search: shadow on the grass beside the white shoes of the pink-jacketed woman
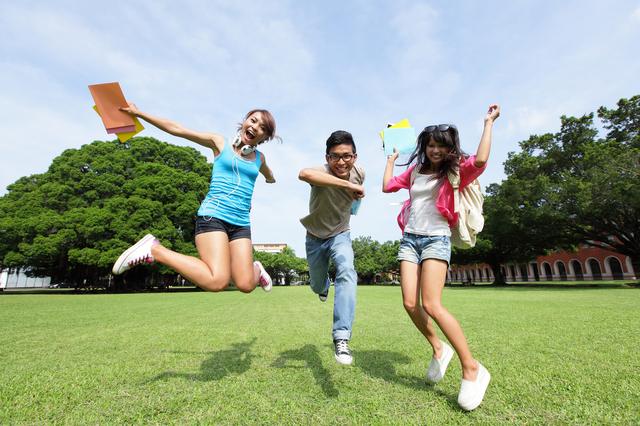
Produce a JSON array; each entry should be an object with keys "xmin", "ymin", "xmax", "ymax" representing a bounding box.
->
[{"xmin": 354, "ymin": 350, "xmax": 458, "ymax": 409}]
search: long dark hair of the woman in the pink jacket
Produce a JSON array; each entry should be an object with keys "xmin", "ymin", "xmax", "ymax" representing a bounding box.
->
[{"xmin": 401, "ymin": 124, "xmax": 467, "ymax": 180}]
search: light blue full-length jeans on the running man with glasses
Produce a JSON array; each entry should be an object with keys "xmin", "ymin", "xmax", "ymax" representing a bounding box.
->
[{"xmin": 306, "ymin": 232, "xmax": 358, "ymax": 340}]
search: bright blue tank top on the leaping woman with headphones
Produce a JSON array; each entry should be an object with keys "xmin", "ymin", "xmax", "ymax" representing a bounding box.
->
[{"xmin": 198, "ymin": 142, "xmax": 261, "ymax": 226}]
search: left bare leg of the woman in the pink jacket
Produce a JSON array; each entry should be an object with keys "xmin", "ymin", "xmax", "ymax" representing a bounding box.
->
[{"xmin": 400, "ymin": 260, "xmax": 442, "ymax": 358}]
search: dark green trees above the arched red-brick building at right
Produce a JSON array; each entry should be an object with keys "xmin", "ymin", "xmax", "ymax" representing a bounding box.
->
[{"xmin": 454, "ymin": 96, "xmax": 640, "ymax": 282}]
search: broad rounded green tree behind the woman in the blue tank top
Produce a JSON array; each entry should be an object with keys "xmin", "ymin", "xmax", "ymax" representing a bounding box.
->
[{"xmin": 0, "ymin": 138, "xmax": 211, "ymax": 286}]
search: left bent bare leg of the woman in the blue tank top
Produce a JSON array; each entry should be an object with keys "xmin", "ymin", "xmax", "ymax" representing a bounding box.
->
[{"xmin": 151, "ymin": 232, "xmax": 231, "ymax": 291}]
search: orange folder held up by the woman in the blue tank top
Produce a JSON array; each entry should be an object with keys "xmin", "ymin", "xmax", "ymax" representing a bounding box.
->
[{"xmin": 89, "ymin": 82, "xmax": 135, "ymax": 133}]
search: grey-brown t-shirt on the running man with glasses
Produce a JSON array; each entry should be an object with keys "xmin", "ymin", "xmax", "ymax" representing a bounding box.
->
[{"xmin": 300, "ymin": 164, "xmax": 364, "ymax": 238}]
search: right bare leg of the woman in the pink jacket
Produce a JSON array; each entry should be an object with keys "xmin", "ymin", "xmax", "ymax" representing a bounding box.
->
[{"xmin": 420, "ymin": 259, "xmax": 478, "ymax": 380}]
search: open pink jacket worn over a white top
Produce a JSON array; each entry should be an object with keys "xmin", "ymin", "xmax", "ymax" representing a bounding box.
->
[{"xmin": 385, "ymin": 155, "xmax": 487, "ymax": 230}]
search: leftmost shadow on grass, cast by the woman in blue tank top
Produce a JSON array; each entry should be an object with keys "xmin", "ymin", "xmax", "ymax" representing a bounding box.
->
[{"xmin": 149, "ymin": 337, "xmax": 256, "ymax": 382}]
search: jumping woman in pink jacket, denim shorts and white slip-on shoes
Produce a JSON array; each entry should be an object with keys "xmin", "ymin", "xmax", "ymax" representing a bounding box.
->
[{"xmin": 382, "ymin": 104, "xmax": 500, "ymax": 411}]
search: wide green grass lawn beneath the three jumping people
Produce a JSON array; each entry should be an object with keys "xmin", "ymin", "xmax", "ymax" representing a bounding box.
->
[{"xmin": 0, "ymin": 286, "xmax": 640, "ymax": 425}]
